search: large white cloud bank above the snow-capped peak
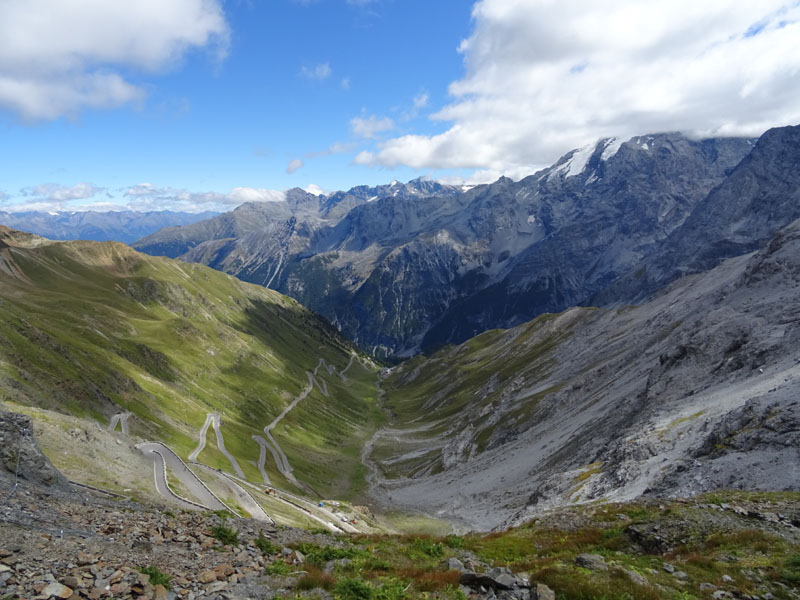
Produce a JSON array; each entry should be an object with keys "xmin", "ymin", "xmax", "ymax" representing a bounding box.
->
[{"xmin": 355, "ymin": 0, "xmax": 800, "ymax": 174}]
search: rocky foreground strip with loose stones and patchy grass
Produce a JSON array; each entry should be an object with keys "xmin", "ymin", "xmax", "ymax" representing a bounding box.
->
[{"xmin": 0, "ymin": 468, "xmax": 800, "ymax": 600}]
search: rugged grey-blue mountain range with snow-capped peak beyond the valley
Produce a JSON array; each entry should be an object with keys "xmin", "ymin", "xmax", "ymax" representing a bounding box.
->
[{"xmin": 134, "ymin": 127, "xmax": 800, "ymax": 357}]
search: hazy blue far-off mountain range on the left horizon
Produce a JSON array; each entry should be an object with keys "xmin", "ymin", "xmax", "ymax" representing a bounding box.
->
[{"xmin": 0, "ymin": 210, "xmax": 219, "ymax": 244}]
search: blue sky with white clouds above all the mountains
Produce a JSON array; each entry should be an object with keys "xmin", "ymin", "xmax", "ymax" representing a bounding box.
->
[{"xmin": 0, "ymin": 0, "xmax": 800, "ymax": 211}]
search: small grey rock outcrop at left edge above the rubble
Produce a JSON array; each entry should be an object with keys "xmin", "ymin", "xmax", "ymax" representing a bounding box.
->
[{"xmin": 0, "ymin": 411, "xmax": 69, "ymax": 488}]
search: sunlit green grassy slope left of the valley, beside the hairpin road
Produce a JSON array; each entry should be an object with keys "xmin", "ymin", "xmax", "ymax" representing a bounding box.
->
[{"xmin": 0, "ymin": 230, "xmax": 380, "ymax": 497}]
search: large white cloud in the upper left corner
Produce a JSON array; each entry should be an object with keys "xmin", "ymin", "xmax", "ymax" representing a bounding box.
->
[{"xmin": 0, "ymin": 0, "xmax": 228, "ymax": 120}]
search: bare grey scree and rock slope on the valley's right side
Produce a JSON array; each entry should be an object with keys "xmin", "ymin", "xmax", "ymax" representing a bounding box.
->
[{"xmin": 374, "ymin": 220, "xmax": 800, "ymax": 528}]
